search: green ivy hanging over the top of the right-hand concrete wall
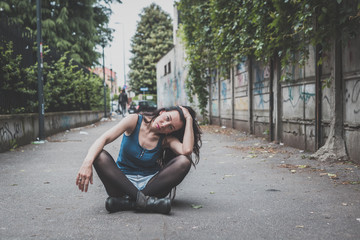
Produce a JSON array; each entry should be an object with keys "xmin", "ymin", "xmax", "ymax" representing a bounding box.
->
[{"xmin": 178, "ymin": 0, "xmax": 360, "ymax": 116}]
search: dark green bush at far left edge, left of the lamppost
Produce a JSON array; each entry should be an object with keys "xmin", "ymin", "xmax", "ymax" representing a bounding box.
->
[{"xmin": 0, "ymin": 41, "xmax": 37, "ymax": 114}]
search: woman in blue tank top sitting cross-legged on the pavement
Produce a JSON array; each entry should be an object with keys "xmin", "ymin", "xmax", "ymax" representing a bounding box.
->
[{"xmin": 76, "ymin": 106, "xmax": 201, "ymax": 214}]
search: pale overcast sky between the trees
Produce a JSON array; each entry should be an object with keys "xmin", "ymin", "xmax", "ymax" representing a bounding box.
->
[{"xmin": 99, "ymin": 0, "xmax": 174, "ymax": 87}]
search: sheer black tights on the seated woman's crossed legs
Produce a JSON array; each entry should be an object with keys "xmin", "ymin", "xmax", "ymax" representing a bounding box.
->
[{"xmin": 93, "ymin": 150, "xmax": 191, "ymax": 199}]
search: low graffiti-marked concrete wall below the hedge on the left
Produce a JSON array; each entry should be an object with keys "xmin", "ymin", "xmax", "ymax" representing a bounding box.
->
[{"xmin": 0, "ymin": 111, "xmax": 104, "ymax": 152}]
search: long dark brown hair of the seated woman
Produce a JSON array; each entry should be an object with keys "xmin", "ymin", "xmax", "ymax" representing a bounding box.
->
[{"xmin": 142, "ymin": 106, "xmax": 202, "ymax": 166}]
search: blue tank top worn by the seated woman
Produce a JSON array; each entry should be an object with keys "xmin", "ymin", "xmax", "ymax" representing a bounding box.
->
[{"xmin": 116, "ymin": 115, "xmax": 164, "ymax": 176}]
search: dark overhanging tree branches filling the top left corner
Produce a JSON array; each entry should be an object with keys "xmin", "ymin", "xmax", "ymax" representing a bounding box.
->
[{"xmin": 0, "ymin": 0, "xmax": 121, "ymax": 66}]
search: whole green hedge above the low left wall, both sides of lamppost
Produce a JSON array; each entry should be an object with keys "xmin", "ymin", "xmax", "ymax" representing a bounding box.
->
[{"xmin": 0, "ymin": 42, "xmax": 110, "ymax": 114}]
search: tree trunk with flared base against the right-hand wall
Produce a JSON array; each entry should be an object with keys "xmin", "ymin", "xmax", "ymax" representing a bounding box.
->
[{"xmin": 312, "ymin": 37, "xmax": 348, "ymax": 162}]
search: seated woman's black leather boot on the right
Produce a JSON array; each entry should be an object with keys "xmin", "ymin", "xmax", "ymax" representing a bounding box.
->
[{"xmin": 136, "ymin": 191, "xmax": 171, "ymax": 214}]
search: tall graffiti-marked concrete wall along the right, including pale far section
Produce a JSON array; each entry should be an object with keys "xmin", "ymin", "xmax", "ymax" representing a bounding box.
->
[{"xmin": 157, "ymin": 31, "xmax": 360, "ymax": 163}]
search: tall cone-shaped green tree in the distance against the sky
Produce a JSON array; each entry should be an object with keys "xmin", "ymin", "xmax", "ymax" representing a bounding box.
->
[{"xmin": 129, "ymin": 3, "xmax": 173, "ymax": 94}]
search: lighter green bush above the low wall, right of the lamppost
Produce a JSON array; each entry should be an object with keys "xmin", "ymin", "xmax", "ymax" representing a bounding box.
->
[{"xmin": 28, "ymin": 50, "xmax": 106, "ymax": 112}]
